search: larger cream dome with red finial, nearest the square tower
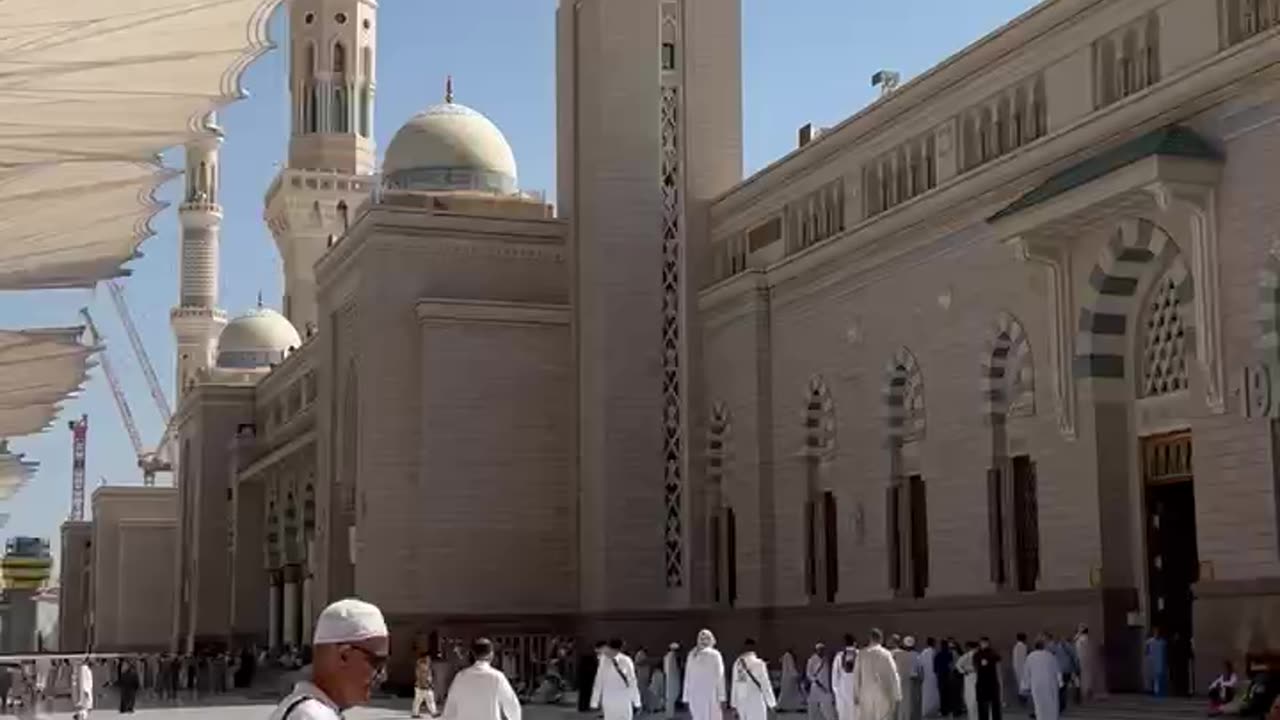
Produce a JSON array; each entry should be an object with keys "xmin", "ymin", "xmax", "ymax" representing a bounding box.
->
[{"xmin": 383, "ymin": 90, "xmax": 517, "ymax": 195}]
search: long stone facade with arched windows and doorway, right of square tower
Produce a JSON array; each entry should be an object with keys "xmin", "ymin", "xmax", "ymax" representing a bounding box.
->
[{"xmin": 700, "ymin": 1, "xmax": 1280, "ymax": 688}]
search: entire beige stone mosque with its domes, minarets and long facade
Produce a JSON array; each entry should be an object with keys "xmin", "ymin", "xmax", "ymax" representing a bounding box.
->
[{"xmin": 63, "ymin": 0, "xmax": 1280, "ymax": 691}]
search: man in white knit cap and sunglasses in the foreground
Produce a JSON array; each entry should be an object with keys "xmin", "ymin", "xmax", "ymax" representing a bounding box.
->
[{"xmin": 271, "ymin": 598, "xmax": 390, "ymax": 720}]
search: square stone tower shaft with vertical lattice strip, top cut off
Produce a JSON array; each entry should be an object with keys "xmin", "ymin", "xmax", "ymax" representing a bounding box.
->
[{"xmin": 557, "ymin": 0, "xmax": 742, "ymax": 611}]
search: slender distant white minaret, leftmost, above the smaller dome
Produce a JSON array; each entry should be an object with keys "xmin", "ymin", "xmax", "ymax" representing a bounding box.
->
[{"xmin": 169, "ymin": 114, "xmax": 227, "ymax": 401}]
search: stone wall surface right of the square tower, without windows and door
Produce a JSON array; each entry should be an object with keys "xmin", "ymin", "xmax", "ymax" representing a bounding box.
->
[{"xmin": 701, "ymin": 0, "xmax": 1280, "ymax": 686}]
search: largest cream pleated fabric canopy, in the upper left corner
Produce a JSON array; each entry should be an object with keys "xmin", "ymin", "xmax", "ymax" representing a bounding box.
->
[{"xmin": 0, "ymin": 0, "xmax": 279, "ymax": 290}]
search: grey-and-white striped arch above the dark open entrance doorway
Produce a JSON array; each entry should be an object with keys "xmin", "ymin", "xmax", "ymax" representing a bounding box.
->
[{"xmin": 1074, "ymin": 218, "xmax": 1196, "ymax": 380}]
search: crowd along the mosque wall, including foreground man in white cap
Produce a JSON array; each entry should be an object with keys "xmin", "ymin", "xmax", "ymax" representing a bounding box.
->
[{"xmin": 273, "ymin": 600, "xmax": 1111, "ymax": 720}]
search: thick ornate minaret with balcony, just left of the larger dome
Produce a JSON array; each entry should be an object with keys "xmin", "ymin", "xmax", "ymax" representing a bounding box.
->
[{"xmin": 265, "ymin": 0, "xmax": 378, "ymax": 337}]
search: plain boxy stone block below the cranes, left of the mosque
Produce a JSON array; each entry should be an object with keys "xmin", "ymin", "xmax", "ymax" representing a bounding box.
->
[{"xmin": 88, "ymin": 487, "xmax": 178, "ymax": 652}]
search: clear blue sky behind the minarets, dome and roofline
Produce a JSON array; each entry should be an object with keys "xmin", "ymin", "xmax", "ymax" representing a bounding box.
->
[{"xmin": 0, "ymin": 0, "xmax": 1036, "ymax": 557}]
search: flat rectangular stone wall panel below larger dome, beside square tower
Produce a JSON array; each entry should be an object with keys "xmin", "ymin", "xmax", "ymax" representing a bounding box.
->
[{"xmin": 412, "ymin": 309, "xmax": 577, "ymax": 615}]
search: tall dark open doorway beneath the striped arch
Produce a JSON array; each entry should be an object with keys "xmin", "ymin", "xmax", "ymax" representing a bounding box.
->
[{"xmin": 1142, "ymin": 432, "xmax": 1199, "ymax": 694}]
